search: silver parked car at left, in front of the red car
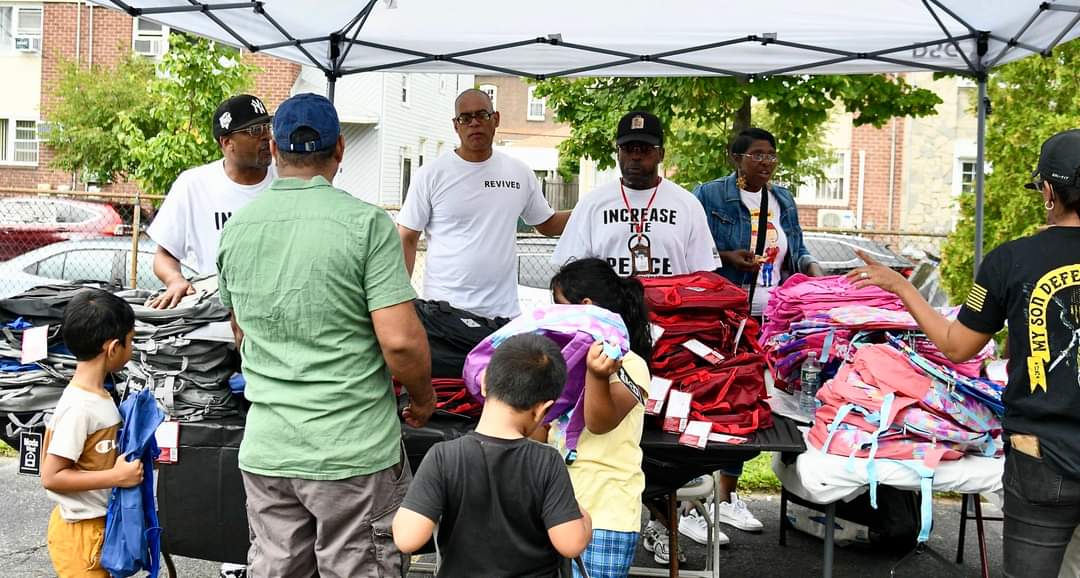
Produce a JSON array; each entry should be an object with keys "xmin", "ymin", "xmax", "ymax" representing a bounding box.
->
[{"xmin": 0, "ymin": 238, "xmax": 195, "ymax": 298}]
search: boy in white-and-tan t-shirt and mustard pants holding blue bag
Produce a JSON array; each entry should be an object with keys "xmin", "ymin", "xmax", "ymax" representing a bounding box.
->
[{"xmin": 41, "ymin": 290, "xmax": 143, "ymax": 578}]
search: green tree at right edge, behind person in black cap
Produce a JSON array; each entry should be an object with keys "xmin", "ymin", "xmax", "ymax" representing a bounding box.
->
[{"xmin": 942, "ymin": 41, "xmax": 1080, "ymax": 303}]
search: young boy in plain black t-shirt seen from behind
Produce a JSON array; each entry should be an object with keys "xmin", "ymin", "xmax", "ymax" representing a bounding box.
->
[{"xmin": 393, "ymin": 335, "xmax": 592, "ymax": 577}]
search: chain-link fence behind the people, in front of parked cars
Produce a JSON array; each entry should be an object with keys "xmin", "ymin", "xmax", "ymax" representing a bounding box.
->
[{"xmin": 0, "ymin": 189, "xmax": 945, "ymax": 305}]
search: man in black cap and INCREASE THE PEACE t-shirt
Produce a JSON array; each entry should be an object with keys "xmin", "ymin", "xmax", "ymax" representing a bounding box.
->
[{"xmin": 552, "ymin": 112, "xmax": 716, "ymax": 277}]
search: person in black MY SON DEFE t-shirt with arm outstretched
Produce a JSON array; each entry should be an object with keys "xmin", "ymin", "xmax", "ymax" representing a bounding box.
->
[{"xmin": 849, "ymin": 130, "xmax": 1080, "ymax": 578}]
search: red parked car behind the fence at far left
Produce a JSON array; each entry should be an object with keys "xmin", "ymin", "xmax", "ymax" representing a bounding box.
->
[{"xmin": 0, "ymin": 197, "xmax": 124, "ymax": 260}]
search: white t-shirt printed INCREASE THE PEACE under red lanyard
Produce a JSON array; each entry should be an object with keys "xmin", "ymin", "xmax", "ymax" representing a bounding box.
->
[{"xmin": 552, "ymin": 178, "xmax": 716, "ymax": 277}]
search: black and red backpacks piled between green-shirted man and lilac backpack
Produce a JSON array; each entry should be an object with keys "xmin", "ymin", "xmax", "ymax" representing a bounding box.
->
[{"xmin": 408, "ymin": 299, "xmax": 510, "ymax": 417}]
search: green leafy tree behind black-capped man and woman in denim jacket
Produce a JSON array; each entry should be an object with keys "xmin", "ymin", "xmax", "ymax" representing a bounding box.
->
[{"xmin": 537, "ymin": 76, "xmax": 941, "ymax": 187}]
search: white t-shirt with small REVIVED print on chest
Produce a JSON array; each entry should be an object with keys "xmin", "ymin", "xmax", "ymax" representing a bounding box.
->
[{"xmin": 397, "ymin": 151, "xmax": 555, "ymax": 317}]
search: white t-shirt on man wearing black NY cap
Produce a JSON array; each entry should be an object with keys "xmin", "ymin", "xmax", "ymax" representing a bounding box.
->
[{"xmin": 146, "ymin": 159, "xmax": 276, "ymax": 274}]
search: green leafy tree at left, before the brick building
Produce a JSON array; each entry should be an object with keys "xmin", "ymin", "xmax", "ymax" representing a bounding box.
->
[{"xmin": 46, "ymin": 33, "xmax": 254, "ymax": 193}]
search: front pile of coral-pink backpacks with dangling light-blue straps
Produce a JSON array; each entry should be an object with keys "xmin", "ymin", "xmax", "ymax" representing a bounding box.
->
[{"xmin": 807, "ymin": 337, "xmax": 1001, "ymax": 541}]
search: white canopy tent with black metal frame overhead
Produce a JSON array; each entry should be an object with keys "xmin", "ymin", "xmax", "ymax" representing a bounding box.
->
[{"xmin": 92, "ymin": 0, "xmax": 1080, "ymax": 272}]
